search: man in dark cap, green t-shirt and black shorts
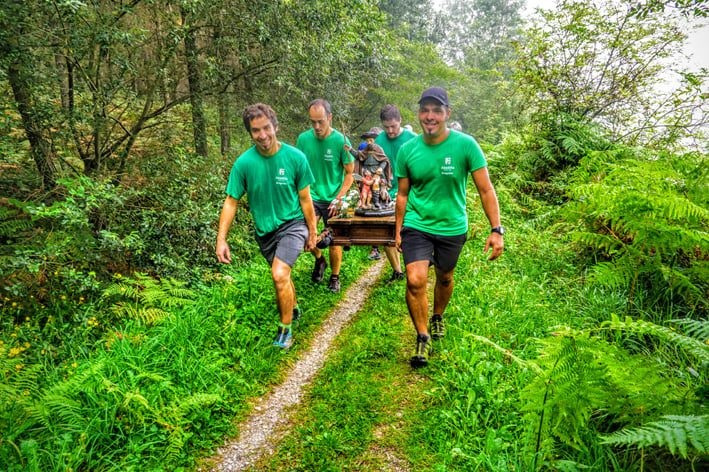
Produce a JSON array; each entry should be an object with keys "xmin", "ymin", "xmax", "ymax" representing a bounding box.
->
[{"xmin": 395, "ymin": 87, "xmax": 504, "ymax": 367}]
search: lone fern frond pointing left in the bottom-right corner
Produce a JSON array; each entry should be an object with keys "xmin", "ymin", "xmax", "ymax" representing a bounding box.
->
[{"xmin": 602, "ymin": 415, "xmax": 709, "ymax": 459}]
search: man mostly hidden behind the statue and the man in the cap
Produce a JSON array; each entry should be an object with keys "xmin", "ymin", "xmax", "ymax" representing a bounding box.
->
[{"xmin": 370, "ymin": 105, "xmax": 416, "ymax": 282}]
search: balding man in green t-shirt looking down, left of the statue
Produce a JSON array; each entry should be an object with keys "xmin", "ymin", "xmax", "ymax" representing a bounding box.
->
[{"xmin": 295, "ymin": 98, "xmax": 354, "ymax": 292}]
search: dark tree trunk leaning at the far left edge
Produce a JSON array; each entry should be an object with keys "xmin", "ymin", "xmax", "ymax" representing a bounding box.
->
[{"xmin": 7, "ymin": 55, "xmax": 57, "ymax": 190}]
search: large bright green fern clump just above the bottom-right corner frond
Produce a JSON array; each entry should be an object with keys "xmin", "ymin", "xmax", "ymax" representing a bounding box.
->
[{"xmin": 520, "ymin": 318, "xmax": 696, "ymax": 469}]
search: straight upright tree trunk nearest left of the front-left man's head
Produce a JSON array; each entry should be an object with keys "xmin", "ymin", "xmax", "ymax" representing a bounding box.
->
[{"xmin": 182, "ymin": 9, "xmax": 207, "ymax": 157}]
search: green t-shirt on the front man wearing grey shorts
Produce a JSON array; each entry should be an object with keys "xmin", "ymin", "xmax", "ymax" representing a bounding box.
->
[{"xmin": 226, "ymin": 142, "xmax": 313, "ymax": 236}]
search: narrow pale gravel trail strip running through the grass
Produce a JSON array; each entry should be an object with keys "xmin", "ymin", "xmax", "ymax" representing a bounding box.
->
[{"xmin": 211, "ymin": 258, "xmax": 388, "ymax": 472}]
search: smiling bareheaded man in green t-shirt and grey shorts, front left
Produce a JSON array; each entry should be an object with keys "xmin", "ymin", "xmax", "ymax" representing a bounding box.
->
[{"xmin": 216, "ymin": 103, "xmax": 317, "ymax": 349}]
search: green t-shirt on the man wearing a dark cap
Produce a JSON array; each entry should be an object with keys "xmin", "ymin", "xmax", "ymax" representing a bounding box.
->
[{"xmin": 396, "ymin": 130, "xmax": 487, "ymax": 236}]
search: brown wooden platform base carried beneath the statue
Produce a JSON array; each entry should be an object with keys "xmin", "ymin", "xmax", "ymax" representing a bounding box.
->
[{"xmin": 328, "ymin": 215, "xmax": 395, "ymax": 246}]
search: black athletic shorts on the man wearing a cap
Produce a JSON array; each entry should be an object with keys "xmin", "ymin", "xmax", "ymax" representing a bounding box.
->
[{"xmin": 401, "ymin": 226, "xmax": 467, "ymax": 272}]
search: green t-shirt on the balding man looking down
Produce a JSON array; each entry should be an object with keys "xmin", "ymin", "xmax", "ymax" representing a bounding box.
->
[{"xmin": 295, "ymin": 128, "xmax": 354, "ymax": 202}]
